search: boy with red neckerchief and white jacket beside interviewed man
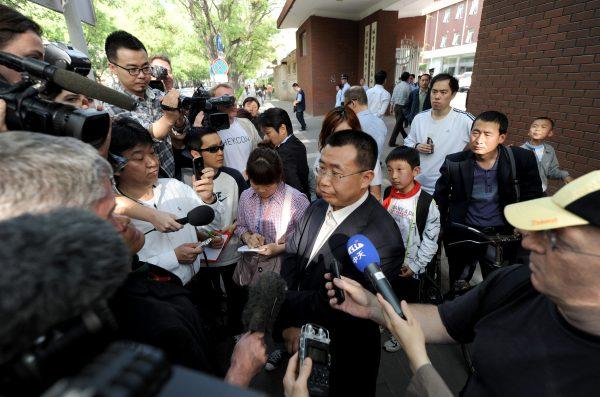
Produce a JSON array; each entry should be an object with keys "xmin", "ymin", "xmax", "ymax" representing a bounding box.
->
[{"xmin": 383, "ymin": 146, "xmax": 440, "ymax": 352}]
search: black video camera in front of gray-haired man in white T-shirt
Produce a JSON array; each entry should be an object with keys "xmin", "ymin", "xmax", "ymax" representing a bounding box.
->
[{"xmin": 161, "ymin": 87, "xmax": 235, "ymax": 131}]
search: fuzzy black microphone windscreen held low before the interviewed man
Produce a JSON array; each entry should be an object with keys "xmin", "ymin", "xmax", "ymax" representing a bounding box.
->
[{"xmin": 242, "ymin": 271, "xmax": 287, "ymax": 332}]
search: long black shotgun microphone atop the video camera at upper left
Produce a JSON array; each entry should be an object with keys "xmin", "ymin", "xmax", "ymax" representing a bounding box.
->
[{"xmin": 0, "ymin": 51, "xmax": 137, "ymax": 110}]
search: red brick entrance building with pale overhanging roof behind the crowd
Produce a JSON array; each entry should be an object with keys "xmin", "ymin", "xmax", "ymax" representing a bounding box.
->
[{"xmin": 277, "ymin": 0, "xmax": 426, "ymax": 115}]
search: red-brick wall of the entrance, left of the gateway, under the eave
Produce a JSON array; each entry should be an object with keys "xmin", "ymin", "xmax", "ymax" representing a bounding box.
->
[{"xmin": 296, "ymin": 16, "xmax": 359, "ymax": 115}]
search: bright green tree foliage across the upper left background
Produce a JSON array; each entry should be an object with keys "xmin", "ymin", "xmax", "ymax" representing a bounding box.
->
[{"xmin": 0, "ymin": 0, "xmax": 284, "ymax": 81}]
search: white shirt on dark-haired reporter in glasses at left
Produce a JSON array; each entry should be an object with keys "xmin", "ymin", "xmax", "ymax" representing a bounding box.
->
[{"xmin": 132, "ymin": 178, "xmax": 223, "ymax": 285}]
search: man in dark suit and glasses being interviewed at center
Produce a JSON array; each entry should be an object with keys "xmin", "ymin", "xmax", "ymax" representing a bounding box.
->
[{"xmin": 276, "ymin": 131, "xmax": 404, "ymax": 396}]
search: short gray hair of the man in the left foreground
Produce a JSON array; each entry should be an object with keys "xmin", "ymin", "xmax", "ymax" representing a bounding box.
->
[{"xmin": 0, "ymin": 131, "xmax": 114, "ymax": 220}]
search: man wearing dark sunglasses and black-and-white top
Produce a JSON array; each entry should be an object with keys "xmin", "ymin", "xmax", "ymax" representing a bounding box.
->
[{"xmin": 187, "ymin": 128, "xmax": 248, "ymax": 335}]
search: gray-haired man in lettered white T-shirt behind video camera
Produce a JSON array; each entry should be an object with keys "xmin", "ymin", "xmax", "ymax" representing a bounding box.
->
[{"xmin": 209, "ymin": 83, "xmax": 262, "ymax": 178}]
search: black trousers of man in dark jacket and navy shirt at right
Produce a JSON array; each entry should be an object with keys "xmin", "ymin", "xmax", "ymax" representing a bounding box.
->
[{"xmin": 444, "ymin": 225, "xmax": 520, "ymax": 288}]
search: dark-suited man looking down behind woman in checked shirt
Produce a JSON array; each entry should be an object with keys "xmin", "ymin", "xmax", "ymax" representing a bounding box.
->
[{"xmin": 259, "ymin": 108, "xmax": 310, "ymax": 200}]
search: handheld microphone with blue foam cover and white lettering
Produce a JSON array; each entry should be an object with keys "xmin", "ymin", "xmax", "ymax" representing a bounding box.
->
[{"xmin": 346, "ymin": 234, "xmax": 404, "ymax": 317}]
